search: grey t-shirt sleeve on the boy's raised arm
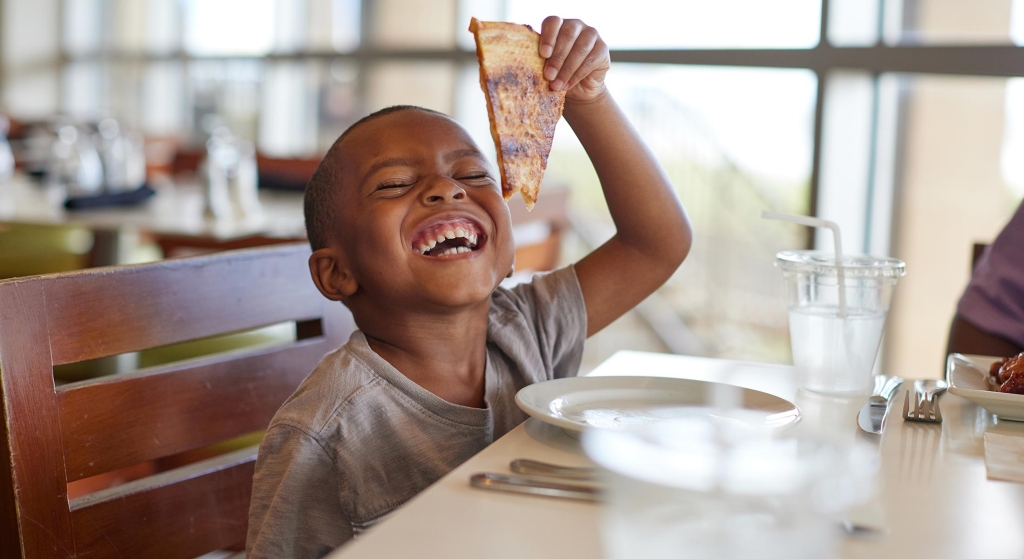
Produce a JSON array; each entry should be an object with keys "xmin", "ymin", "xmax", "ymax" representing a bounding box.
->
[{"xmin": 493, "ymin": 265, "xmax": 587, "ymax": 378}]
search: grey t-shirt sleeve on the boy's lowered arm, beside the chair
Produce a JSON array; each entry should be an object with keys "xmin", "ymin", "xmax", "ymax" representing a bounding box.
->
[{"xmin": 246, "ymin": 424, "xmax": 352, "ymax": 559}]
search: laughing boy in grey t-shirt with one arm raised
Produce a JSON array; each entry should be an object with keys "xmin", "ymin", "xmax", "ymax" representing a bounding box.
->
[{"xmin": 248, "ymin": 16, "xmax": 691, "ymax": 559}]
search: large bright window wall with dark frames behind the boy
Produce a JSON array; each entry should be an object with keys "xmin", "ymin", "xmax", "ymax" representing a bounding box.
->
[{"xmin": 3, "ymin": 0, "xmax": 1024, "ymax": 377}]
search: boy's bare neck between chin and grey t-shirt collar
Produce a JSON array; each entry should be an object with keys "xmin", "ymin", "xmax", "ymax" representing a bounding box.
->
[{"xmin": 359, "ymin": 300, "xmax": 490, "ymax": 407}]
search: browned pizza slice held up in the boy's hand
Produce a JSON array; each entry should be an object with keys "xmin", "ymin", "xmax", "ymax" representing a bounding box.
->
[{"xmin": 469, "ymin": 17, "xmax": 565, "ymax": 209}]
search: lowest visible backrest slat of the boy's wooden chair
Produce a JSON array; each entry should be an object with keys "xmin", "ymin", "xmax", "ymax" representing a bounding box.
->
[{"xmin": 72, "ymin": 447, "xmax": 256, "ymax": 559}]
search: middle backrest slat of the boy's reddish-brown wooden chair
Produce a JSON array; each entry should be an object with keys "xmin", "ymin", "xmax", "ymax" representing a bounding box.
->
[{"xmin": 57, "ymin": 340, "xmax": 323, "ymax": 481}]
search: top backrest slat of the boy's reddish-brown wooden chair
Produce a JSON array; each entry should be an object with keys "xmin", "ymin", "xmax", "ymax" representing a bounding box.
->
[{"xmin": 44, "ymin": 246, "xmax": 323, "ymax": 364}]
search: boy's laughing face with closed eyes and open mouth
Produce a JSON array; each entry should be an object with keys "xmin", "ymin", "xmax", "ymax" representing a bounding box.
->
[{"xmin": 332, "ymin": 110, "xmax": 514, "ymax": 310}]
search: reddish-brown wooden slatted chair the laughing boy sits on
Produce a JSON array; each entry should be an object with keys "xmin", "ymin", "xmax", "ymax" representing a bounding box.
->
[{"xmin": 0, "ymin": 245, "xmax": 354, "ymax": 558}]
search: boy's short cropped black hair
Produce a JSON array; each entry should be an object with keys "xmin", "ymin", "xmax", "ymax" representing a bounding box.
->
[{"xmin": 302, "ymin": 104, "xmax": 451, "ymax": 251}]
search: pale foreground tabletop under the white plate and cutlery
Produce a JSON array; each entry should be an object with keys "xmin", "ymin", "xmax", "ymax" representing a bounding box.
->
[{"xmin": 328, "ymin": 351, "xmax": 1024, "ymax": 559}]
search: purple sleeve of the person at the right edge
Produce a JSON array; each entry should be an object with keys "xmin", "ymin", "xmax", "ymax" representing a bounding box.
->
[{"xmin": 956, "ymin": 203, "xmax": 1024, "ymax": 346}]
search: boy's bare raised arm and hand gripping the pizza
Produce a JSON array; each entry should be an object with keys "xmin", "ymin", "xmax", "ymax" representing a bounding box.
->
[{"xmin": 541, "ymin": 16, "xmax": 693, "ymax": 336}]
